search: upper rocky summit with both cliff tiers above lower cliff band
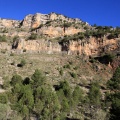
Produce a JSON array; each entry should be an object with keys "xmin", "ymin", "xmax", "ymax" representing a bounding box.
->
[{"xmin": 0, "ymin": 13, "xmax": 89, "ymax": 38}]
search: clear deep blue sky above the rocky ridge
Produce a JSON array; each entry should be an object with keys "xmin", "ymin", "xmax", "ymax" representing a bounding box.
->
[{"xmin": 0, "ymin": 0, "xmax": 120, "ymax": 27}]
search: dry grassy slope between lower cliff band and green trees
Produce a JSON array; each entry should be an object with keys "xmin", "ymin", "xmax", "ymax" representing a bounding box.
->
[{"xmin": 0, "ymin": 53, "xmax": 111, "ymax": 85}]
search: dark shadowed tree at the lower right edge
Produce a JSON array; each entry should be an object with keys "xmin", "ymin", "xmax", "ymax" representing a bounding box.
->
[{"xmin": 106, "ymin": 67, "xmax": 120, "ymax": 120}]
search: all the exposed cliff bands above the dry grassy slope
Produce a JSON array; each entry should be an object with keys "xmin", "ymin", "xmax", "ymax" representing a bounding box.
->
[{"xmin": 0, "ymin": 13, "xmax": 120, "ymax": 56}]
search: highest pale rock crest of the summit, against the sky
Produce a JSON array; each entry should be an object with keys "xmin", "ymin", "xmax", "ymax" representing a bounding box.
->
[{"xmin": 21, "ymin": 13, "xmax": 82, "ymax": 29}]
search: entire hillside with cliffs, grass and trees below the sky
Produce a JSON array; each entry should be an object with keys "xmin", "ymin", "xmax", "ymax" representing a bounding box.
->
[{"xmin": 0, "ymin": 13, "xmax": 120, "ymax": 120}]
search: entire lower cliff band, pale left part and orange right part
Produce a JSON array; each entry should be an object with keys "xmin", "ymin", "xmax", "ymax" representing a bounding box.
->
[{"xmin": 17, "ymin": 37, "xmax": 120, "ymax": 56}]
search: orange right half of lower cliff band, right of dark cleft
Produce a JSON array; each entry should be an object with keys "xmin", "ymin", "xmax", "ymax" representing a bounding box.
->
[{"xmin": 68, "ymin": 37, "xmax": 120, "ymax": 56}]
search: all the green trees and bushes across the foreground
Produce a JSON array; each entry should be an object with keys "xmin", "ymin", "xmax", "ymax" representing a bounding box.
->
[{"xmin": 0, "ymin": 63, "xmax": 120, "ymax": 120}]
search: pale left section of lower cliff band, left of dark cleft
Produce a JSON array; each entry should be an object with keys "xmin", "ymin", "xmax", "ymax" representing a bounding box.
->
[{"xmin": 15, "ymin": 39, "xmax": 61, "ymax": 53}]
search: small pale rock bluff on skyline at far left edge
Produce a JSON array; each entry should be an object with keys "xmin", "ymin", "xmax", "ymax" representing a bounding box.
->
[{"xmin": 0, "ymin": 19, "xmax": 20, "ymax": 28}]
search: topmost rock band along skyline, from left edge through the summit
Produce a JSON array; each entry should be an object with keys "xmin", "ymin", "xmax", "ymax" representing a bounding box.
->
[{"xmin": 0, "ymin": 13, "xmax": 82, "ymax": 29}]
